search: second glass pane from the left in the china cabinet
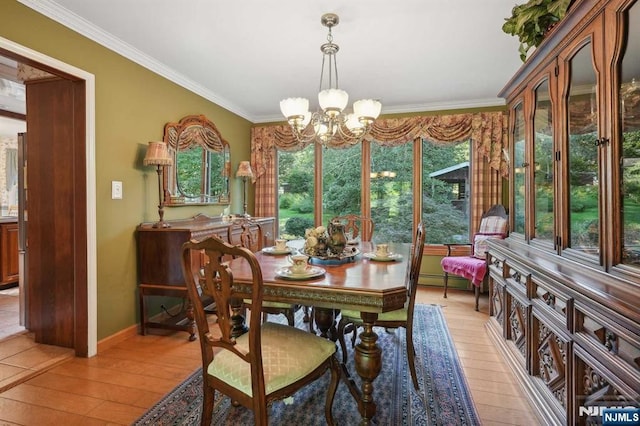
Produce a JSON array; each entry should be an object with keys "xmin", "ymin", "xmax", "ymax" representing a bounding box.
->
[{"xmin": 533, "ymin": 80, "xmax": 554, "ymax": 241}]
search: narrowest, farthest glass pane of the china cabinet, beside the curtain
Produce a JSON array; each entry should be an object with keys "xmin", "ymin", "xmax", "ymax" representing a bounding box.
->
[{"xmin": 513, "ymin": 103, "xmax": 526, "ymax": 234}]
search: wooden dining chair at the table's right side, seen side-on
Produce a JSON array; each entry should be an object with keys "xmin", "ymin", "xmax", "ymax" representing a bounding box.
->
[{"xmin": 337, "ymin": 222, "xmax": 425, "ymax": 390}]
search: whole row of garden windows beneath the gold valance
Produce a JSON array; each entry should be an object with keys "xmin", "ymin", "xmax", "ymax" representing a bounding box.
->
[{"xmin": 278, "ymin": 135, "xmax": 480, "ymax": 244}]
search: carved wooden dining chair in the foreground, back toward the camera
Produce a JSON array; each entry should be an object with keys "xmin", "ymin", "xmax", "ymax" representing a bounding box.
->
[{"xmin": 182, "ymin": 236, "xmax": 340, "ymax": 425}]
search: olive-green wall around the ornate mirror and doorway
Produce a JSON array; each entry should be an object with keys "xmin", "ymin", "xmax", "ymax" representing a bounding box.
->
[{"xmin": 0, "ymin": 0, "xmax": 252, "ymax": 340}]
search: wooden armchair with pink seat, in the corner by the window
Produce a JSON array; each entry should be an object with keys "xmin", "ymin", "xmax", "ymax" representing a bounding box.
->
[{"xmin": 440, "ymin": 204, "xmax": 508, "ymax": 311}]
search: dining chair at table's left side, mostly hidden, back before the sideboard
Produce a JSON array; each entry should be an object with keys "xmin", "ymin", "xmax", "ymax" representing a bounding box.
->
[{"xmin": 227, "ymin": 218, "xmax": 299, "ymax": 327}]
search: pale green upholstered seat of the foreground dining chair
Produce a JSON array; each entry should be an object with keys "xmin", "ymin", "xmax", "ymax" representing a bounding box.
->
[{"xmin": 207, "ymin": 322, "xmax": 336, "ymax": 396}]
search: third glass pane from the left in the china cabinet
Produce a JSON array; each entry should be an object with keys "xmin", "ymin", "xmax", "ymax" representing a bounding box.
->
[{"xmin": 567, "ymin": 43, "xmax": 600, "ymax": 255}]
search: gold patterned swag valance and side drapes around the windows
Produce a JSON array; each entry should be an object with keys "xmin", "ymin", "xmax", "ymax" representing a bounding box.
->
[{"xmin": 251, "ymin": 111, "xmax": 508, "ymax": 223}]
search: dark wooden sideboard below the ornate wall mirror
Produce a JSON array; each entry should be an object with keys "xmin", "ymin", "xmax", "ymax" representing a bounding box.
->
[{"xmin": 137, "ymin": 214, "xmax": 275, "ymax": 340}]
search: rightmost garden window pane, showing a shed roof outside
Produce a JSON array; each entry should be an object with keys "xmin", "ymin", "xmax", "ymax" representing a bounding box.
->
[{"xmin": 422, "ymin": 140, "xmax": 470, "ymax": 244}]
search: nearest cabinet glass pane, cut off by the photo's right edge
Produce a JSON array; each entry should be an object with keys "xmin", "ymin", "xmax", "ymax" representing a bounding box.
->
[{"xmin": 619, "ymin": 2, "xmax": 640, "ymax": 266}]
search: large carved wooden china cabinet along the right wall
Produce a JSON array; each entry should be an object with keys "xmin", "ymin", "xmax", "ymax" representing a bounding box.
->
[{"xmin": 488, "ymin": 0, "xmax": 640, "ymax": 425}]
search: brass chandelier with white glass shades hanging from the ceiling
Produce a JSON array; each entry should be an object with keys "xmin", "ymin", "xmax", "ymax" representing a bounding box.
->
[{"xmin": 280, "ymin": 13, "xmax": 382, "ymax": 146}]
